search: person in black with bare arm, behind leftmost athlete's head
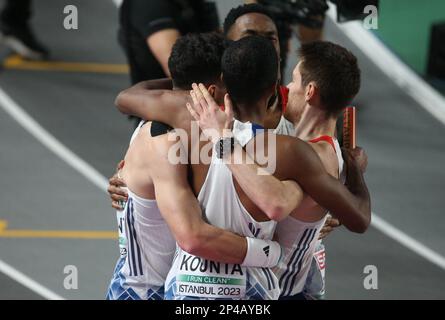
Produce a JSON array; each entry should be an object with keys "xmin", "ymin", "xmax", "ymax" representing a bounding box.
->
[{"xmin": 119, "ymin": 0, "xmax": 219, "ymax": 84}]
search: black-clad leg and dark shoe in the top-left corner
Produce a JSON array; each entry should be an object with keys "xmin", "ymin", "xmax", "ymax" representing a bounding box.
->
[{"xmin": 0, "ymin": 0, "xmax": 49, "ymax": 60}]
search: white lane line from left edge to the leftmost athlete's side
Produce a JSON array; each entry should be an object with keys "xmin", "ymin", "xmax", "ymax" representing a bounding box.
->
[{"xmin": 0, "ymin": 88, "xmax": 108, "ymax": 191}]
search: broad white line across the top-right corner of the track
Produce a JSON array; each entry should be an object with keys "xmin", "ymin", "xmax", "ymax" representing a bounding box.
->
[{"xmin": 327, "ymin": 4, "xmax": 445, "ymax": 125}]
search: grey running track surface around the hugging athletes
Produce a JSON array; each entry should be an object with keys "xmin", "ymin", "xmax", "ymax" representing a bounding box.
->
[{"xmin": 0, "ymin": 0, "xmax": 445, "ymax": 299}]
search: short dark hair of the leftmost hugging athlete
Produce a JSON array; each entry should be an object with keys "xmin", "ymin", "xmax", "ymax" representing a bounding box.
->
[{"xmin": 168, "ymin": 32, "xmax": 227, "ymax": 90}]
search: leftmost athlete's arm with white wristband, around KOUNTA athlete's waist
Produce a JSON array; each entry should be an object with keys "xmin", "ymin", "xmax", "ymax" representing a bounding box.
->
[{"xmin": 149, "ymin": 135, "xmax": 281, "ymax": 267}]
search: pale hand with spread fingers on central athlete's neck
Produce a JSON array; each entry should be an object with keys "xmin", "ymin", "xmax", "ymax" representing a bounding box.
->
[{"xmin": 187, "ymin": 83, "xmax": 233, "ymax": 143}]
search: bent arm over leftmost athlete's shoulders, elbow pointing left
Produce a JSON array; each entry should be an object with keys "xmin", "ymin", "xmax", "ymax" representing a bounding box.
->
[{"xmin": 115, "ymin": 79, "xmax": 191, "ymax": 129}]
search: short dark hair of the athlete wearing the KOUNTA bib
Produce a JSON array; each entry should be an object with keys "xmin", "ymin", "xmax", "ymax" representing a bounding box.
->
[{"xmin": 221, "ymin": 36, "xmax": 278, "ymax": 104}]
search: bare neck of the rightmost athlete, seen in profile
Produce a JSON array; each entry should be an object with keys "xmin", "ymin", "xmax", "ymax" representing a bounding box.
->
[{"xmin": 294, "ymin": 104, "xmax": 337, "ymax": 141}]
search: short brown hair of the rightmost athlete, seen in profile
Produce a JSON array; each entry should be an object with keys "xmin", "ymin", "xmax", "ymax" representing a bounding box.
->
[{"xmin": 298, "ymin": 41, "xmax": 360, "ymax": 116}]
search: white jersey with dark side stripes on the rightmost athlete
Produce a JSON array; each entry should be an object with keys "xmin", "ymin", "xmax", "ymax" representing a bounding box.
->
[{"xmin": 274, "ymin": 139, "xmax": 344, "ymax": 297}]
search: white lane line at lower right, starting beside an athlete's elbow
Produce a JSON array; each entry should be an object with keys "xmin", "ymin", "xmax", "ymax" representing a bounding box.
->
[{"xmin": 371, "ymin": 213, "xmax": 445, "ymax": 270}]
